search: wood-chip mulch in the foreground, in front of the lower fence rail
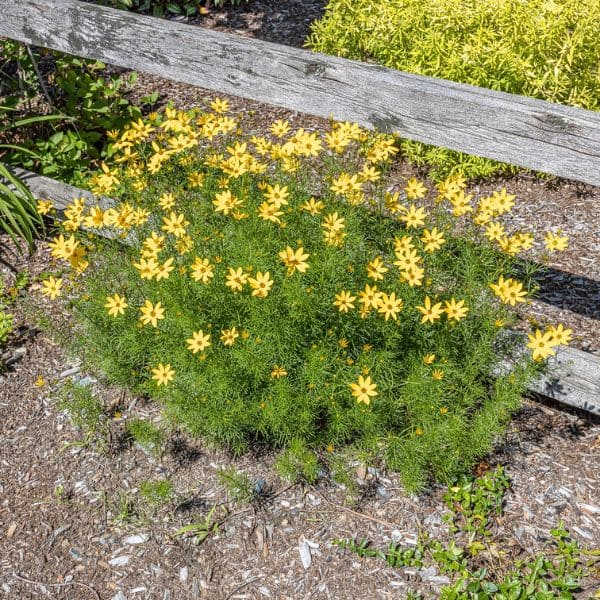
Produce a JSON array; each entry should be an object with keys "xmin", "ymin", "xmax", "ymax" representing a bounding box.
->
[{"xmin": 0, "ymin": 238, "xmax": 600, "ymax": 600}]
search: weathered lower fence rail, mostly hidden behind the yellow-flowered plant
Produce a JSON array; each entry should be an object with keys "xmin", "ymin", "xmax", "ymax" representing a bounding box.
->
[{"xmin": 7, "ymin": 169, "xmax": 600, "ymax": 416}]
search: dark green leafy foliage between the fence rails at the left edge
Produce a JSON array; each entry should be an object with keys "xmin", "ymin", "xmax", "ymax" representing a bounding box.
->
[{"xmin": 0, "ymin": 40, "xmax": 157, "ymax": 185}]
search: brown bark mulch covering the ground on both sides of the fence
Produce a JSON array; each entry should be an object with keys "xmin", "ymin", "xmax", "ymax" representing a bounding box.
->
[{"xmin": 0, "ymin": 0, "xmax": 600, "ymax": 600}]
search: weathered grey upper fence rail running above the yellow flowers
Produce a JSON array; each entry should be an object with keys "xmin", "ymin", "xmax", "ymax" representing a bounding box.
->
[{"xmin": 0, "ymin": 0, "xmax": 600, "ymax": 185}]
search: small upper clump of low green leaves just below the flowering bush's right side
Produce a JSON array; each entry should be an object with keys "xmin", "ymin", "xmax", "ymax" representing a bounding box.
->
[{"xmin": 443, "ymin": 465, "xmax": 510, "ymax": 536}]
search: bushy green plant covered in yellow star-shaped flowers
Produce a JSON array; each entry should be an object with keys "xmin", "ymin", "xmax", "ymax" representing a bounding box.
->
[{"xmin": 38, "ymin": 100, "xmax": 570, "ymax": 489}]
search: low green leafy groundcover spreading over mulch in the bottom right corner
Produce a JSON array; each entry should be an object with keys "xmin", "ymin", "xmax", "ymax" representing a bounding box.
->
[{"xmin": 333, "ymin": 467, "xmax": 600, "ymax": 600}]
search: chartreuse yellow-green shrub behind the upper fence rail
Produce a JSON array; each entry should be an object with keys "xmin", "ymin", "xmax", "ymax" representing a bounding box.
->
[{"xmin": 308, "ymin": 0, "xmax": 600, "ymax": 179}]
